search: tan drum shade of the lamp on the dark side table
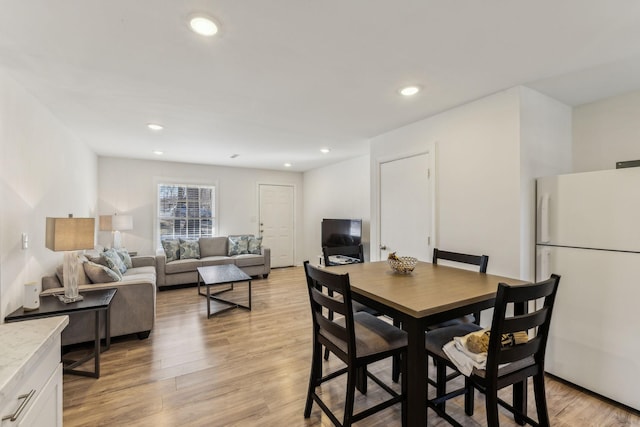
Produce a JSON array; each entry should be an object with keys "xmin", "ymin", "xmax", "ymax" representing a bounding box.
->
[{"xmin": 45, "ymin": 217, "xmax": 96, "ymax": 252}]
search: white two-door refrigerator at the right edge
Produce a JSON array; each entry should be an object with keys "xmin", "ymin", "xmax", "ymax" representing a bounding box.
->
[{"xmin": 536, "ymin": 168, "xmax": 640, "ymax": 410}]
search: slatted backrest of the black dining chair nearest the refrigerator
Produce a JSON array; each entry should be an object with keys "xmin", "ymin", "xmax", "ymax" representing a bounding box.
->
[{"xmin": 486, "ymin": 274, "xmax": 560, "ymax": 378}]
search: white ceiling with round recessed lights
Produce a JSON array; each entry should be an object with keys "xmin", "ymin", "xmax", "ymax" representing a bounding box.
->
[{"xmin": 0, "ymin": 0, "xmax": 640, "ymax": 171}]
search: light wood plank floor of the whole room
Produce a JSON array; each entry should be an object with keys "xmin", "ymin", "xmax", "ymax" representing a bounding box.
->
[{"xmin": 64, "ymin": 267, "xmax": 640, "ymax": 427}]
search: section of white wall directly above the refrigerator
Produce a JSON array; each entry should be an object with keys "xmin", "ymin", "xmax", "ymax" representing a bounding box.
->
[{"xmin": 573, "ymin": 91, "xmax": 640, "ymax": 172}]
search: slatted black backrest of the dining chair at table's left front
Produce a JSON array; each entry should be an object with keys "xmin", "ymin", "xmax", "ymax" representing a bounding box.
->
[{"xmin": 304, "ymin": 261, "xmax": 356, "ymax": 363}]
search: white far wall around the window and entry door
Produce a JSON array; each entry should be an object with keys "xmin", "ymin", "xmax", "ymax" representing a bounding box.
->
[{"xmin": 98, "ymin": 157, "xmax": 304, "ymax": 264}]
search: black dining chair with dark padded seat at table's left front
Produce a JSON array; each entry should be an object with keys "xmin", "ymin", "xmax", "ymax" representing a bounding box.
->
[{"xmin": 304, "ymin": 261, "xmax": 407, "ymax": 427}]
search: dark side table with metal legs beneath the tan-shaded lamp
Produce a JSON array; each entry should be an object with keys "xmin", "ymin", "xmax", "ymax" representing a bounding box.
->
[{"xmin": 4, "ymin": 289, "xmax": 117, "ymax": 378}]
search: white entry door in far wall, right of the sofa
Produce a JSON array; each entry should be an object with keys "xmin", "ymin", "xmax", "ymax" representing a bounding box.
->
[{"xmin": 259, "ymin": 184, "xmax": 294, "ymax": 267}]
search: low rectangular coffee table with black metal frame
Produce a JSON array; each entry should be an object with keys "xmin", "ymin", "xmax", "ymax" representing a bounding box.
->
[{"xmin": 198, "ymin": 264, "xmax": 251, "ymax": 319}]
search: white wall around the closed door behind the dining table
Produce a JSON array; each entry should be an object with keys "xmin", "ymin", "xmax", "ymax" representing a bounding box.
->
[{"xmin": 371, "ymin": 88, "xmax": 520, "ymax": 276}]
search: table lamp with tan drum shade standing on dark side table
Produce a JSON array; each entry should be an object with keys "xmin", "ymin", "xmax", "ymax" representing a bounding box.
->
[{"xmin": 45, "ymin": 215, "xmax": 96, "ymax": 303}]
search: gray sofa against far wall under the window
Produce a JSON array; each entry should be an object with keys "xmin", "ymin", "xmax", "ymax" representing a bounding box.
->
[{"xmin": 156, "ymin": 235, "xmax": 271, "ymax": 288}]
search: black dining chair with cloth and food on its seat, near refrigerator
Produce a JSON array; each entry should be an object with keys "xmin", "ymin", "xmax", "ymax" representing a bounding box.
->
[{"xmin": 425, "ymin": 274, "xmax": 560, "ymax": 427}]
